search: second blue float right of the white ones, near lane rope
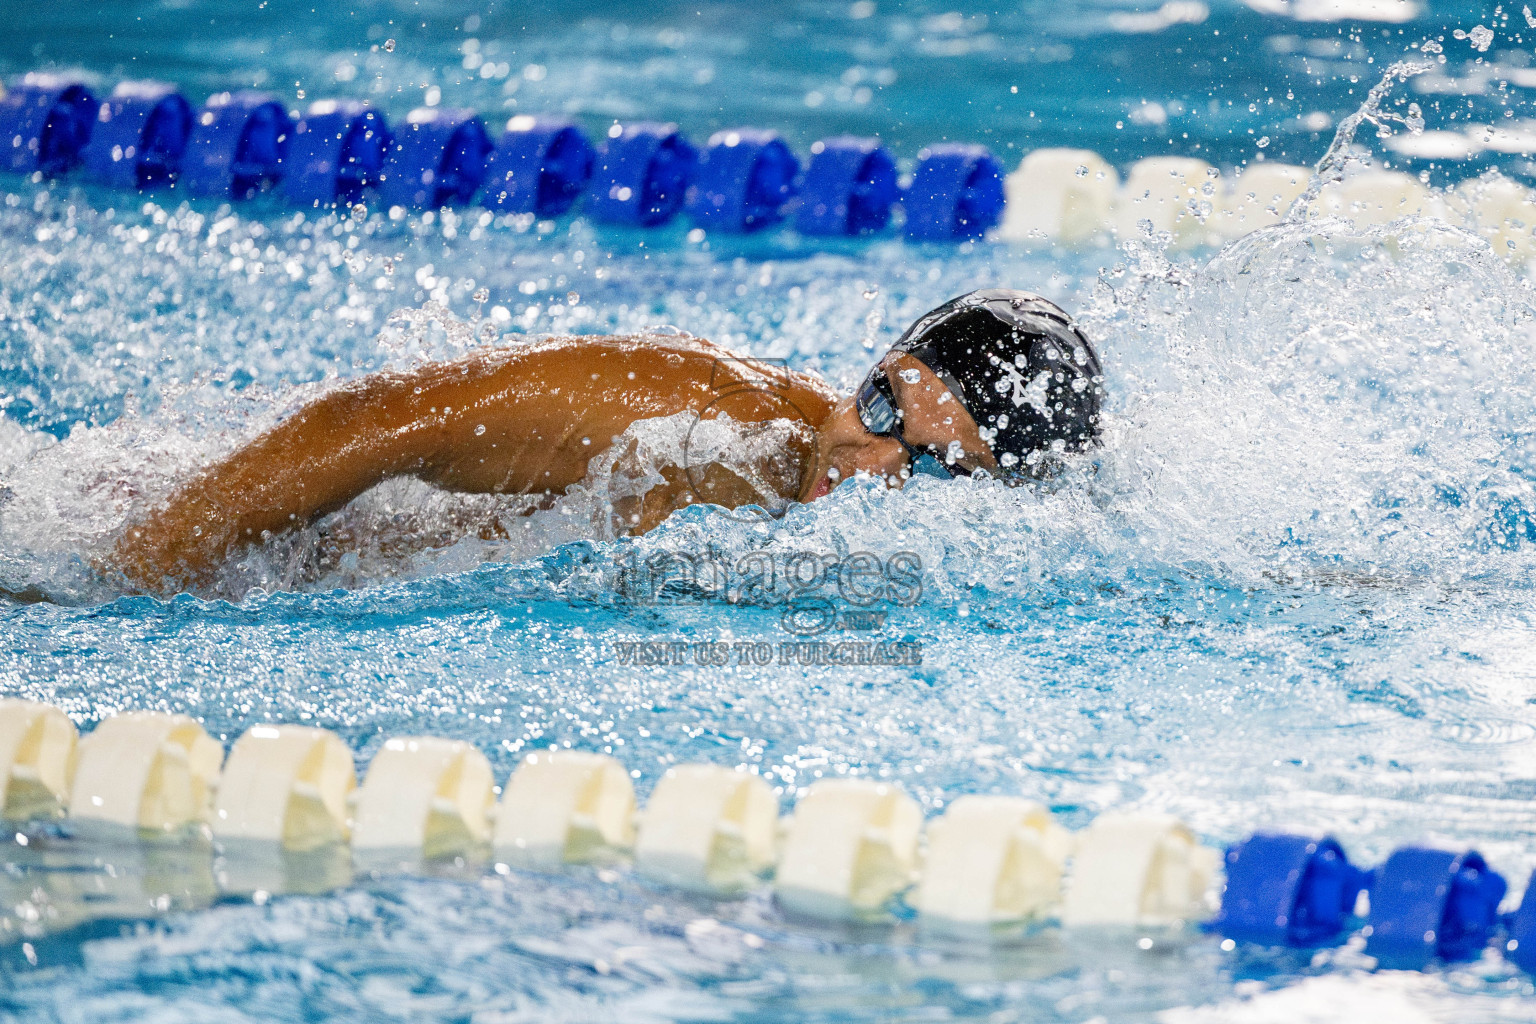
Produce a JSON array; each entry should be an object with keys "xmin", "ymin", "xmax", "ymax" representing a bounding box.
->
[{"xmin": 1366, "ymin": 846, "xmax": 1508, "ymax": 967}]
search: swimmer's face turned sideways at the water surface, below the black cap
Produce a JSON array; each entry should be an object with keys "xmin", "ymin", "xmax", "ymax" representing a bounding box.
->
[{"xmin": 800, "ymin": 352, "xmax": 998, "ymax": 502}]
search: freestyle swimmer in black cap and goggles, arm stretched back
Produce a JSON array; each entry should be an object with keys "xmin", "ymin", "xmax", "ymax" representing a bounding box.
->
[{"xmin": 114, "ymin": 289, "xmax": 1103, "ymax": 593}]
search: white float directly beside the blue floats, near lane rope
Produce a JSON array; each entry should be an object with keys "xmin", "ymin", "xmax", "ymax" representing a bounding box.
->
[{"xmin": 1061, "ymin": 811, "xmax": 1221, "ymax": 927}]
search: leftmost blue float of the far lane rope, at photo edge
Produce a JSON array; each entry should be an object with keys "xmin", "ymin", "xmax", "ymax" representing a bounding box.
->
[{"xmin": 0, "ymin": 71, "xmax": 97, "ymax": 175}]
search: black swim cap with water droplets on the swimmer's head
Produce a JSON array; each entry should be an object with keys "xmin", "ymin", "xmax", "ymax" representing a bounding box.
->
[{"xmin": 891, "ymin": 289, "xmax": 1104, "ymax": 477}]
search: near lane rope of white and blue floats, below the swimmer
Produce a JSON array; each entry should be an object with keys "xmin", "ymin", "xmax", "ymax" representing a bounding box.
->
[{"xmin": 0, "ymin": 699, "xmax": 1536, "ymax": 973}]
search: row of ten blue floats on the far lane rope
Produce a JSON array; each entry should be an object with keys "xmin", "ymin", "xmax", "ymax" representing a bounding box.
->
[{"xmin": 9, "ymin": 72, "xmax": 1005, "ymax": 241}]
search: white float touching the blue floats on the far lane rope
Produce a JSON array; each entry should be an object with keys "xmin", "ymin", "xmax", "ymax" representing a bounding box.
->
[{"xmin": 997, "ymin": 149, "xmax": 1120, "ymax": 246}]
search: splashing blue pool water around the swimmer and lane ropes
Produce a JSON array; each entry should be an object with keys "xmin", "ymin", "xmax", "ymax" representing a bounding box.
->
[{"xmin": 0, "ymin": 0, "xmax": 1536, "ymax": 1022}]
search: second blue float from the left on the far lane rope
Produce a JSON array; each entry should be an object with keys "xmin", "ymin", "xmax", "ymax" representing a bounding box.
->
[{"xmin": 80, "ymin": 81, "xmax": 192, "ymax": 190}]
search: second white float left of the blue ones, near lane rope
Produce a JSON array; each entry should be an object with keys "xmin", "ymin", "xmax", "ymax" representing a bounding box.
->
[{"xmin": 911, "ymin": 797, "xmax": 1072, "ymax": 926}]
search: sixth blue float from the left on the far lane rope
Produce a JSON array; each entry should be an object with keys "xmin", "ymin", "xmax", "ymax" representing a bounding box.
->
[{"xmin": 481, "ymin": 114, "xmax": 596, "ymax": 218}]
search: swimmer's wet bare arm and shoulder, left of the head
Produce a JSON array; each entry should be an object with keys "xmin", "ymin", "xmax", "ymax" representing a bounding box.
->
[{"xmin": 114, "ymin": 339, "xmax": 829, "ymax": 591}]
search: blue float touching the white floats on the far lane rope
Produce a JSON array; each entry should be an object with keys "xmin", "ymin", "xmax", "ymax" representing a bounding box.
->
[{"xmin": 902, "ymin": 143, "xmax": 1005, "ymax": 241}]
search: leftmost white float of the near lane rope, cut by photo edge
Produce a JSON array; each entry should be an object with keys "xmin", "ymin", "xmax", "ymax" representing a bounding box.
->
[{"xmin": 0, "ymin": 697, "xmax": 78, "ymax": 821}]
